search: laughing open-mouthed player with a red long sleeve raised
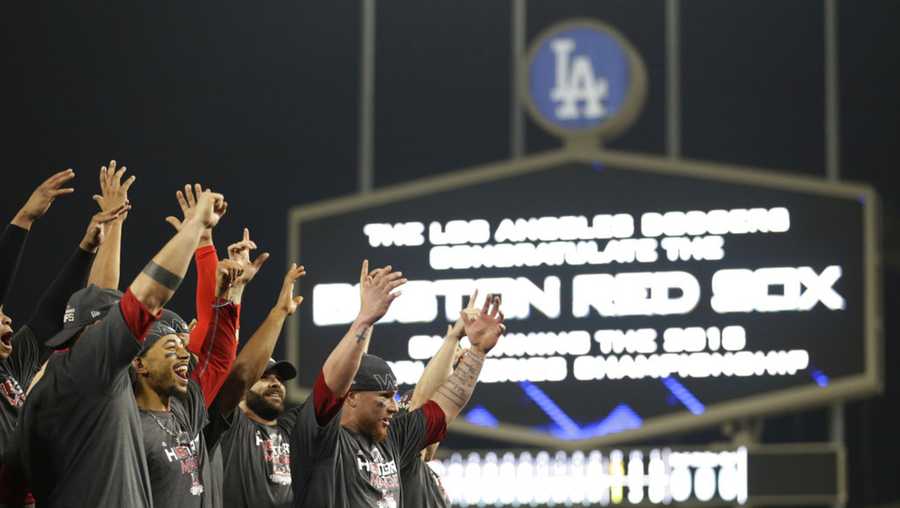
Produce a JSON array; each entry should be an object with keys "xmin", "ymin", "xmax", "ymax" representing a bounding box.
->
[{"xmin": 131, "ymin": 252, "xmax": 243, "ymax": 508}]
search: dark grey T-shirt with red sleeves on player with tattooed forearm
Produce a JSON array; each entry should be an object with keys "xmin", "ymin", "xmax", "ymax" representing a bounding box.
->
[{"xmin": 291, "ymin": 374, "xmax": 446, "ymax": 508}]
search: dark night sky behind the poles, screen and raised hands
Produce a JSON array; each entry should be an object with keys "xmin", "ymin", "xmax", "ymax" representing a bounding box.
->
[{"xmin": 0, "ymin": 0, "xmax": 900, "ymax": 505}]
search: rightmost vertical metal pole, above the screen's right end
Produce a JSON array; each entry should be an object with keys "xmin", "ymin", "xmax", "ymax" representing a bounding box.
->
[{"xmin": 825, "ymin": 0, "xmax": 841, "ymax": 180}]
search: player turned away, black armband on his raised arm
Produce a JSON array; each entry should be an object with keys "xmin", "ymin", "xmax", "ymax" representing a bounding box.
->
[{"xmin": 20, "ymin": 184, "xmax": 224, "ymax": 508}]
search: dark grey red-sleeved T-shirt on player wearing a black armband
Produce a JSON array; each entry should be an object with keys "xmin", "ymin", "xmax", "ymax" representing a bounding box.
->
[{"xmin": 19, "ymin": 291, "xmax": 155, "ymax": 508}]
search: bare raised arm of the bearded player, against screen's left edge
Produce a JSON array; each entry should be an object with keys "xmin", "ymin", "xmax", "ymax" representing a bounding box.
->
[{"xmin": 216, "ymin": 263, "xmax": 306, "ymax": 414}]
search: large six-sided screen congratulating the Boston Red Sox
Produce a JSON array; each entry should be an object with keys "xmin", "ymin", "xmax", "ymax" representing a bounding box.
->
[{"xmin": 288, "ymin": 151, "xmax": 880, "ymax": 449}]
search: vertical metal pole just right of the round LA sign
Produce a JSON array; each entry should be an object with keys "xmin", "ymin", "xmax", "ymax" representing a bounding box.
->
[{"xmin": 666, "ymin": 0, "xmax": 681, "ymax": 159}]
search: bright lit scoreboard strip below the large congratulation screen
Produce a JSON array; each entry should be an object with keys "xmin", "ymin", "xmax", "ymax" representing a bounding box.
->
[{"xmin": 429, "ymin": 443, "xmax": 847, "ymax": 507}]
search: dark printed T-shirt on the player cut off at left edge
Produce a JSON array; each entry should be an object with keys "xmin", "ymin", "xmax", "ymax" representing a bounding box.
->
[{"xmin": 0, "ymin": 326, "xmax": 47, "ymax": 460}]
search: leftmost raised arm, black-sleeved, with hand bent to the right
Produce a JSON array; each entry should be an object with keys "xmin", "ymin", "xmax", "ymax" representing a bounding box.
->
[{"xmin": 0, "ymin": 169, "xmax": 75, "ymax": 306}]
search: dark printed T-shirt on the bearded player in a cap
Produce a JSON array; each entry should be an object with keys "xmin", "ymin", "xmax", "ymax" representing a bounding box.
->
[{"xmin": 210, "ymin": 403, "xmax": 300, "ymax": 508}]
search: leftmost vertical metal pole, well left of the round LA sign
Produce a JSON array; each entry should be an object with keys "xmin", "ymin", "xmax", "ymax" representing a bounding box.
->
[{"xmin": 357, "ymin": 0, "xmax": 375, "ymax": 192}]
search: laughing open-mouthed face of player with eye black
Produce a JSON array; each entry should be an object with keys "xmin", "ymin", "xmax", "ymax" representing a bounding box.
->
[{"xmin": 141, "ymin": 334, "xmax": 190, "ymax": 396}]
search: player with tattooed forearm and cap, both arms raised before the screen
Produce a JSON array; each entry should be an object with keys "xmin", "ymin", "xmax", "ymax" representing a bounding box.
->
[{"xmin": 291, "ymin": 266, "xmax": 503, "ymax": 508}]
